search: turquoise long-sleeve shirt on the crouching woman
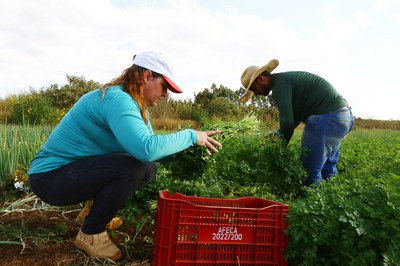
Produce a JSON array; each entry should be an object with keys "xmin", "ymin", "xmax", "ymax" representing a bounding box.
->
[{"xmin": 29, "ymin": 86, "xmax": 197, "ymax": 174}]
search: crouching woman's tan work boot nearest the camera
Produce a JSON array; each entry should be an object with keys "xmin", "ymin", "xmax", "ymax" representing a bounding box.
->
[{"xmin": 74, "ymin": 230, "xmax": 122, "ymax": 261}]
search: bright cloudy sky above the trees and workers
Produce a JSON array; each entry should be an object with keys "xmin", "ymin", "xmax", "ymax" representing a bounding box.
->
[{"xmin": 0, "ymin": 0, "xmax": 400, "ymax": 120}]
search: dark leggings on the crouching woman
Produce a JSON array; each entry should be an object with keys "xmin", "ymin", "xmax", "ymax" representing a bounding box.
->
[{"xmin": 29, "ymin": 154, "xmax": 157, "ymax": 234}]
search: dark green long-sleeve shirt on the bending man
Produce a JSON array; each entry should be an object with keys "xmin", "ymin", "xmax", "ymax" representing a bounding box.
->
[{"xmin": 271, "ymin": 71, "xmax": 347, "ymax": 142}]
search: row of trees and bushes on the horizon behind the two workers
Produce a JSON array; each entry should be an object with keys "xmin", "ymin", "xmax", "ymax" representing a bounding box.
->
[{"xmin": 0, "ymin": 75, "xmax": 279, "ymax": 125}]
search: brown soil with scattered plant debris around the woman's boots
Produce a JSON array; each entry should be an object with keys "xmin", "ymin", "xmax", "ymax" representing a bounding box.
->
[{"xmin": 0, "ymin": 204, "xmax": 151, "ymax": 266}]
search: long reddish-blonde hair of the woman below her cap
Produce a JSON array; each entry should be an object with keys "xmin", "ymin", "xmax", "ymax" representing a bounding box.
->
[{"xmin": 101, "ymin": 65, "xmax": 148, "ymax": 124}]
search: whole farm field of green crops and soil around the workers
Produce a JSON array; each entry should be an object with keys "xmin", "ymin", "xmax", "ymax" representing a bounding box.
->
[{"xmin": 0, "ymin": 123, "xmax": 400, "ymax": 265}]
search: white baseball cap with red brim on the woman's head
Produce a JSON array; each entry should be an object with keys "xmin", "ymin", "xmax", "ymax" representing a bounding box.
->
[{"xmin": 133, "ymin": 52, "xmax": 182, "ymax": 93}]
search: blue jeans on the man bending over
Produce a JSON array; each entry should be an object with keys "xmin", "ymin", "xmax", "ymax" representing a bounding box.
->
[{"xmin": 301, "ymin": 107, "xmax": 354, "ymax": 186}]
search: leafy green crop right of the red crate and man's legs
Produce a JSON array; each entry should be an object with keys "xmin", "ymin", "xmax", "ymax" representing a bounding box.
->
[{"xmin": 286, "ymin": 131, "xmax": 400, "ymax": 265}]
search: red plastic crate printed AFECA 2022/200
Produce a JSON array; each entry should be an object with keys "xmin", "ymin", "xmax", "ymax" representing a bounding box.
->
[{"xmin": 153, "ymin": 190, "xmax": 289, "ymax": 266}]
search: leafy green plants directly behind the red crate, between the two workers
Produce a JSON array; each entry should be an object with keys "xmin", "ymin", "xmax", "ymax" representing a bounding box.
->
[{"xmin": 161, "ymin": 134, "xmax": 306, "ymax": 200}]
